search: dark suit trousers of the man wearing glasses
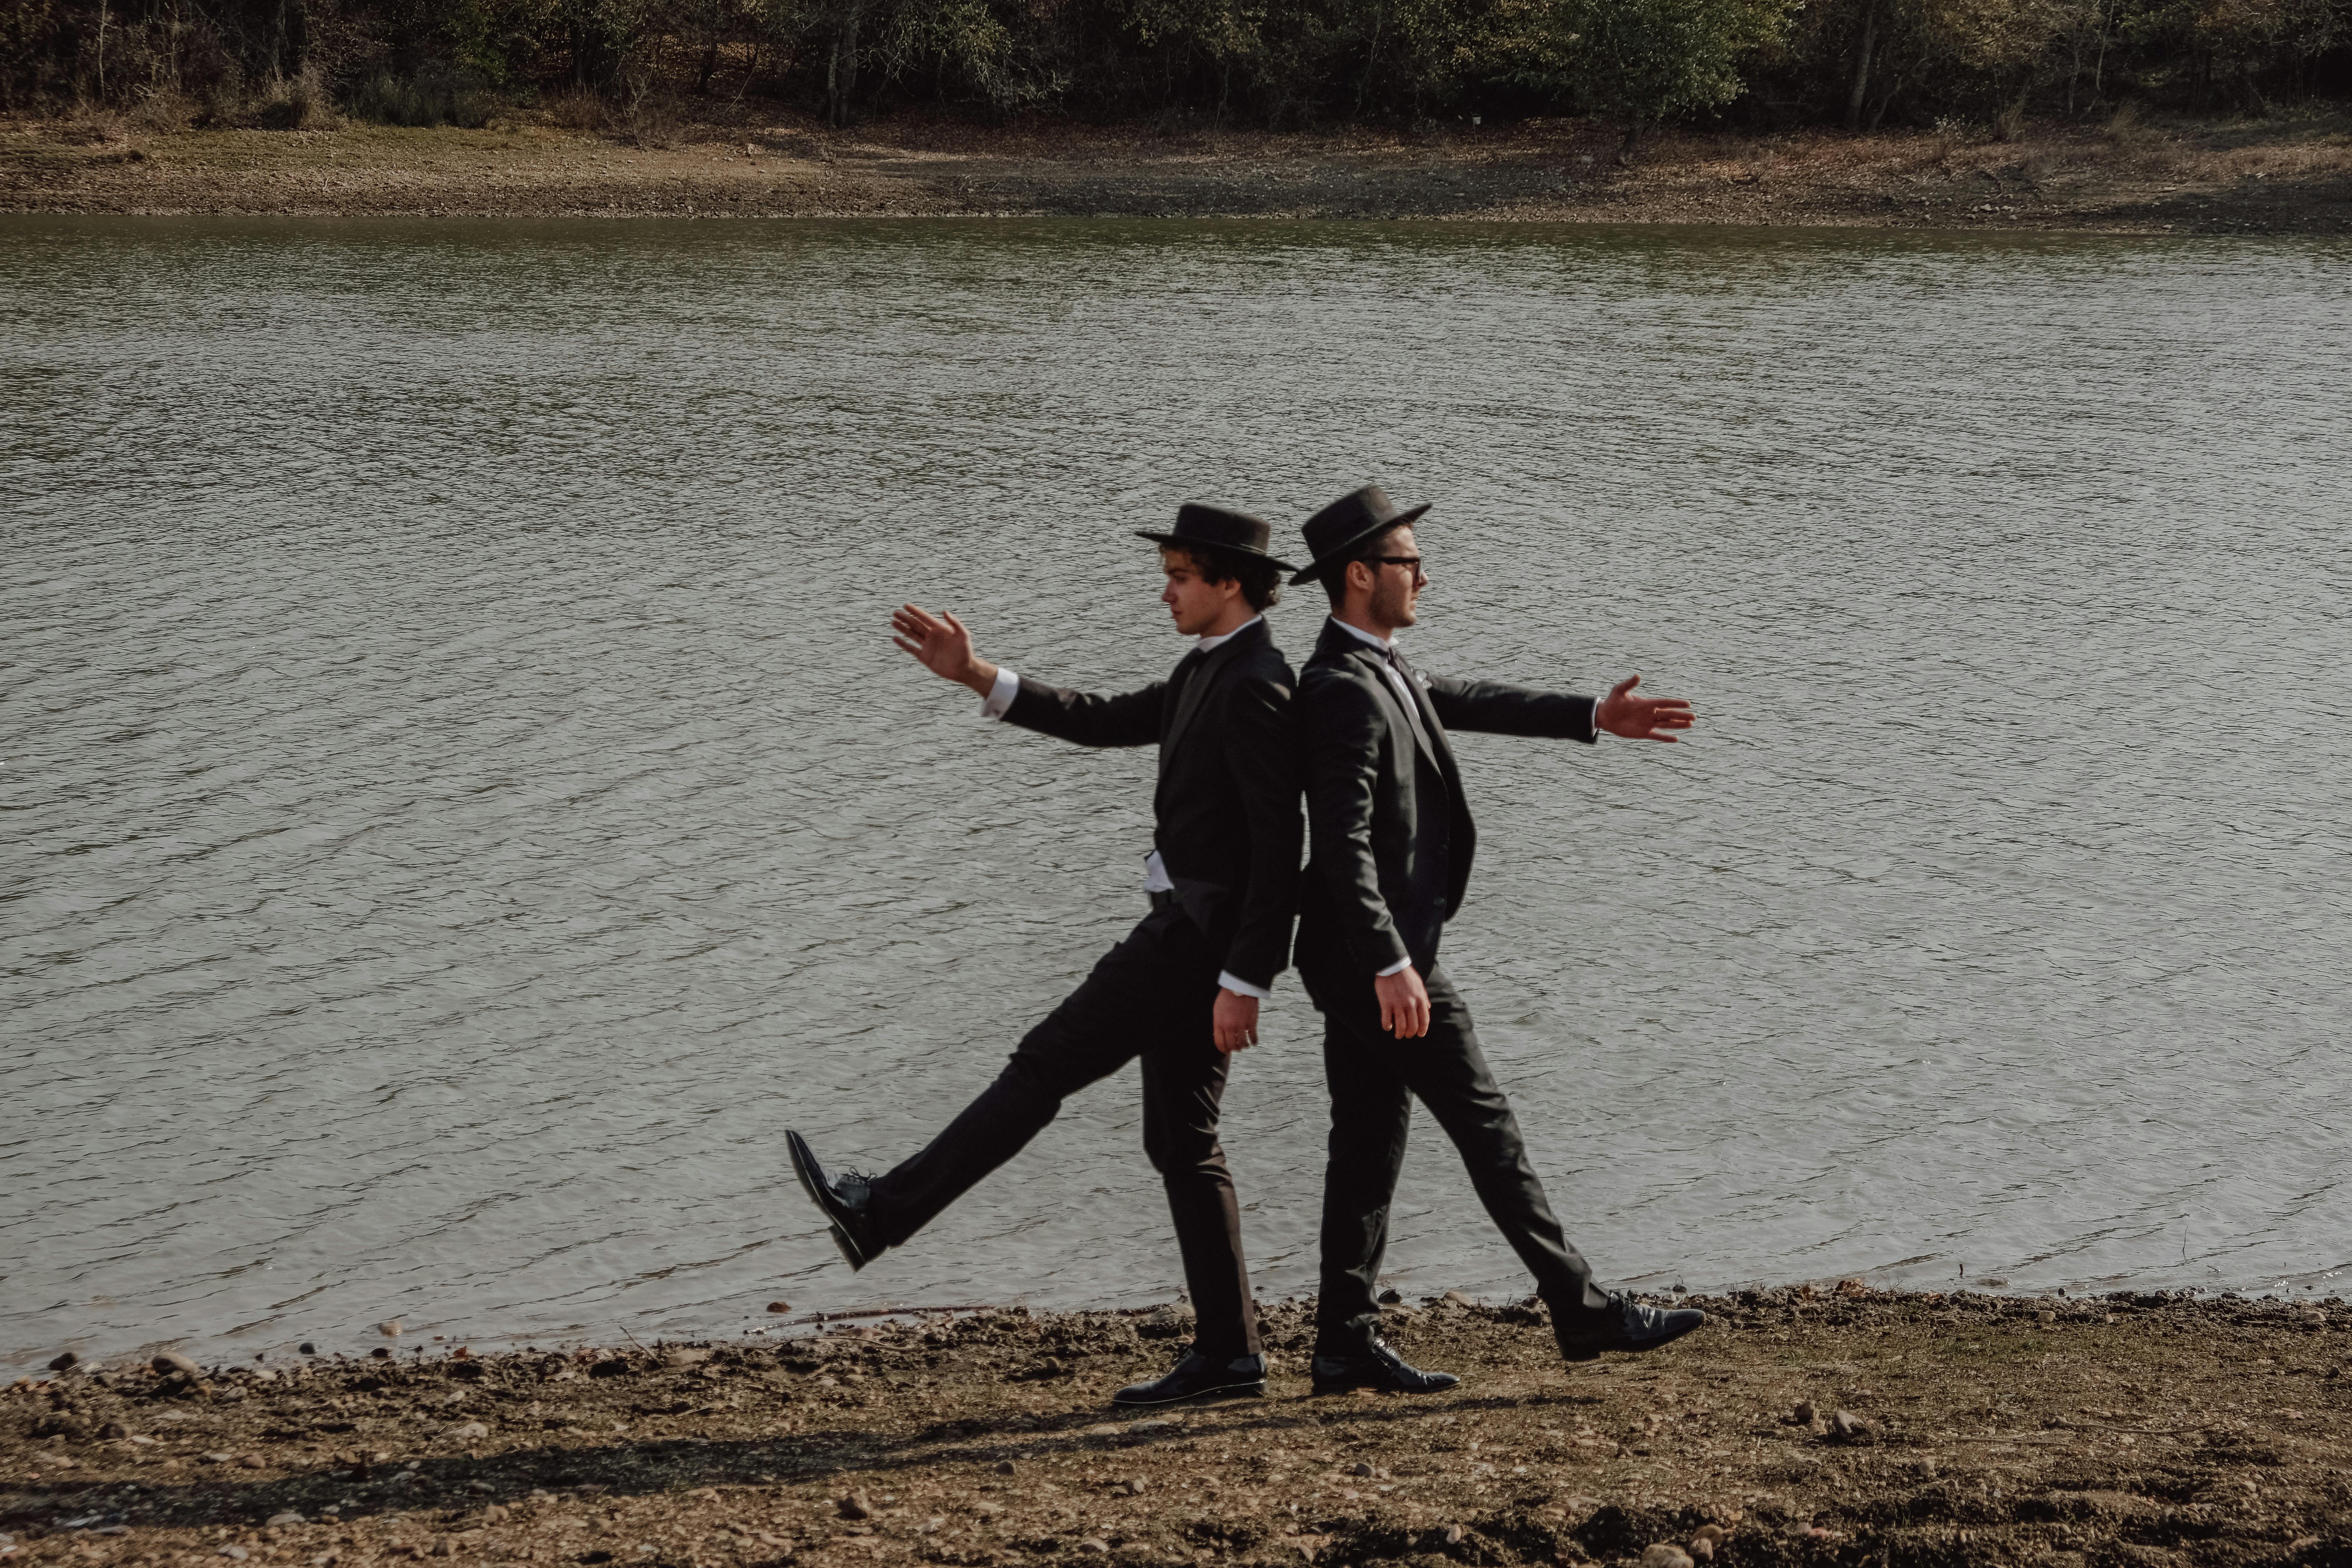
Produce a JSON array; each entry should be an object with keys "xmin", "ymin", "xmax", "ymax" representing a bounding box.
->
[{"xmin": 1301, "ymin": 954, "xmax": 1609, "ymax": 1352}]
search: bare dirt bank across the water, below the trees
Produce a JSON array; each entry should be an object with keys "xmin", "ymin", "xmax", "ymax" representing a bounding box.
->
[{"xmin": 0, "ymin": 113, "xmax": 2352, "ymax": 235}]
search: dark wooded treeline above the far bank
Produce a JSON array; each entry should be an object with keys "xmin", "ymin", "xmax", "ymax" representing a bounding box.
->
[{"xmin": 0, "ymin": 0, "xmax": 2352, "ymax": 129}]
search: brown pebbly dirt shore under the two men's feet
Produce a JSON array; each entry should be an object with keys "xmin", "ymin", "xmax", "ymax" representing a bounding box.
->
[{"xmin": 0, "ymin": 1281, "xmax": 2352, "ymax": 1568}]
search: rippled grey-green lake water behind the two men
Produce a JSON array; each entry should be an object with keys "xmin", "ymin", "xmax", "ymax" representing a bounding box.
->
[{"xmin": 0, "ymin": 219, "xmax": 2352, "ymax": 1366}]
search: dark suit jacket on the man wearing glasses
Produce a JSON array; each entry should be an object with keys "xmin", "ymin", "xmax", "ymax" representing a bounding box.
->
[{"xmin": 1296, "ymin": 623, "xmax": 1597, "ymax": 978}]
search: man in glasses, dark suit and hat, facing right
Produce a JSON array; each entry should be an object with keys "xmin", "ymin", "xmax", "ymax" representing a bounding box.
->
[{"xmin": 1291, "ymin": 487, "xmax": 1705, "ymax": 1394}]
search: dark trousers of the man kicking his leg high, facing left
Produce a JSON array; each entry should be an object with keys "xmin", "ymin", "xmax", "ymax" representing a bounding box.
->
[{"xmin": 873, "ymin": 907, "xmax": 1263, "ymax": 1359}]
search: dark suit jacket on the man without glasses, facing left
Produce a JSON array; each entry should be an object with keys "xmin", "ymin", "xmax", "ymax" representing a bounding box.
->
[{"xmin": 1004, "ymin": 621, "xmax": 1305, "ymax": 987}]
